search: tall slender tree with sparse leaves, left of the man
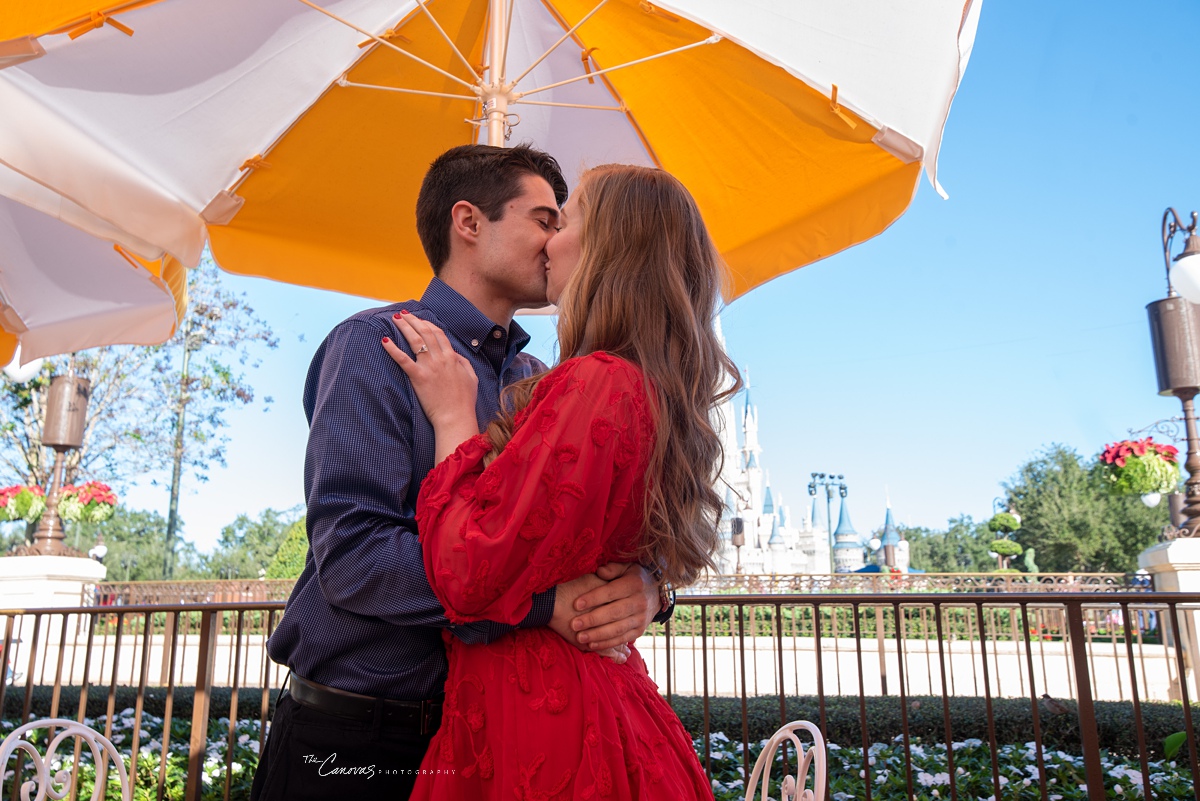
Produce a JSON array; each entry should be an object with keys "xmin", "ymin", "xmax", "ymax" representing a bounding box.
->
[{"xmin": 138, "ymin": 257, "xmax": 278, "ymax": 578}]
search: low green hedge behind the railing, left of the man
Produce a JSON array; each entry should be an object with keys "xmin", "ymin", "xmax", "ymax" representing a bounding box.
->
[{"xmin": 4, "ymin": 685, "xmax": 278, "ymax": 721}]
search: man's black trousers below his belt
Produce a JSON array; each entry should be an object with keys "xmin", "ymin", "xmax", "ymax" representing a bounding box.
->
[{"xmin": 250, "ymin": 693, "xmax": 432, "ymax": 801}]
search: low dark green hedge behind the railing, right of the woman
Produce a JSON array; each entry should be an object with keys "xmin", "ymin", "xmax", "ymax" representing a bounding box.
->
[{"xmin": 673, "ymin": 695, "xmax": 1200, "ymax": 759}]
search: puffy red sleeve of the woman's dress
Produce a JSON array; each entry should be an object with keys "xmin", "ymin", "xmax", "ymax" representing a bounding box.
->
[{"xmin": 416, "ymin": 354, "xmax": 654, "ymax": 624}]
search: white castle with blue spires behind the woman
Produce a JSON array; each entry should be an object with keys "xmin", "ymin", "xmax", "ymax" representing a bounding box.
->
[{"xmin": 715, "ymin": 319, "xmax": 910, "ymax": 574}]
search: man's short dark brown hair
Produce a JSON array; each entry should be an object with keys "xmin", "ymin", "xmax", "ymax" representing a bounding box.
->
[{"xmin": 416, "ymin": 145, "xmax": 566, "ymax": 275}]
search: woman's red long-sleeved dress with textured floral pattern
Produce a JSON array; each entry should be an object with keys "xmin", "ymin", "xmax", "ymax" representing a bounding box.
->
[{"xmin": 412, "ymin": 354, "xmax": 713, "ymax": 801}]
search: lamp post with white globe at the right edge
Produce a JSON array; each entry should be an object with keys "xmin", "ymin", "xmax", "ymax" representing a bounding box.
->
[{"xmin": 1146, "ymin": 209, "xmax": 1200, "ymax": 537}]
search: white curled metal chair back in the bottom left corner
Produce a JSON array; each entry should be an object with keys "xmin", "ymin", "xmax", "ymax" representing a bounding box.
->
[{"xmin": 0, "ymin": 717, "xmax": 133, "ymax": 801}]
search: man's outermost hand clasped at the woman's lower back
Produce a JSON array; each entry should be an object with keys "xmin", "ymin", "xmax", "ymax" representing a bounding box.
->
[{"xmin": 568, "ymin": 562, "xmax": 660, "ymax": 651}]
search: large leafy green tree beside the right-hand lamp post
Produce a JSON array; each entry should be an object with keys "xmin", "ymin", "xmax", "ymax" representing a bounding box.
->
[{"xmin": 1004, "ymin": 445, "xmax": 1168, "ymax": 573}]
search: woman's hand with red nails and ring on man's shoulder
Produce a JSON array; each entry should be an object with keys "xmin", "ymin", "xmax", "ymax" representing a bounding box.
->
[{"xmin": 383, "ymin": 311, "xmax": 479, "ymax": 462}]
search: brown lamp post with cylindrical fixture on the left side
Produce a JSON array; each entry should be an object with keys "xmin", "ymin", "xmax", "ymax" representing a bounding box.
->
[{"xmin": 14, "ymin": 372, "xmax": 90, "ymax": 556}]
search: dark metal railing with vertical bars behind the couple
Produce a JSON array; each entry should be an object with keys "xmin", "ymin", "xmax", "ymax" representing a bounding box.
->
[{"xmin": 0, "ymin": 592, "xmax": 1200, "ymax": 801}]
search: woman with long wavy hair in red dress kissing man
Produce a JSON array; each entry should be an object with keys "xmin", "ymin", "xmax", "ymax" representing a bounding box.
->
[{"xmin": 384, "ymin": 165, "xmax": 738, "ymax": 800}]
